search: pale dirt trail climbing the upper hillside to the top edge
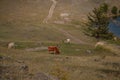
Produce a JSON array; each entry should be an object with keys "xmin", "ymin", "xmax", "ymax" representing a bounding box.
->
[{"xmin": 43, "ymin": 0, "xmax": 57, "ymax": 23}]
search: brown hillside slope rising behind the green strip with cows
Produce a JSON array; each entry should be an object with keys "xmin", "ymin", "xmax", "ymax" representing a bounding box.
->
[{"xmin": 0, "ymin": 0, "xmax": 120, "ymax": 43}]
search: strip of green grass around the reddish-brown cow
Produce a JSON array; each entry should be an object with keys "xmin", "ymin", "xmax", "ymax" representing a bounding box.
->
[{"xmin": 0, "ymin": 42, "xmax": 114, "ymax": 56}]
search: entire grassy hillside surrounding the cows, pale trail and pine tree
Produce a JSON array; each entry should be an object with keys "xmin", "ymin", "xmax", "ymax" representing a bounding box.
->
[{"xmin": 0, "ymin": 0, "xmax": 120, "ymax": 80}]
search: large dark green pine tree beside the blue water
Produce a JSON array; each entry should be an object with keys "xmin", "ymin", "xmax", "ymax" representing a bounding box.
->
[{"xmin": 87, "ymin": 4, "xmax": 112, "ymax": 39}]
